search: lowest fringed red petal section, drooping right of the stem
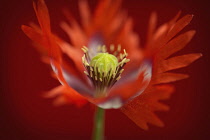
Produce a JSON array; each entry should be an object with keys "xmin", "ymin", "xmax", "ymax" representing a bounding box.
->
[{"xmin": 121, "ymin": 85, "xmax": 174, "ymax": 130}]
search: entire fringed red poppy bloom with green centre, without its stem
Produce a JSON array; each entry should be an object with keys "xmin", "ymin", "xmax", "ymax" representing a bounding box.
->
[{"xmin": 22, "ymin": 0, "xmax": 201, "ymax": 129}]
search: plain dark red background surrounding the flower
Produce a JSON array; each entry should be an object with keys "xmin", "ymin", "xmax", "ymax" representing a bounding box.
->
[{"xmin": 0, "ymin": 0, "xmax": 210, "ymax": 140}]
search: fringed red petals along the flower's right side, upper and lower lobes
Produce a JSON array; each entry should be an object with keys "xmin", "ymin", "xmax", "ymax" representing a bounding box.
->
[{"xmin": 122, "ymin": 12, "xmax": 201, "ymax": 129}]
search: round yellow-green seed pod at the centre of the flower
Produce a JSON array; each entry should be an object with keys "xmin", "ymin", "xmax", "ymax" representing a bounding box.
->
[{"xmin": 90, "ymin": 53, "xmax": 118, "ymax": 77}]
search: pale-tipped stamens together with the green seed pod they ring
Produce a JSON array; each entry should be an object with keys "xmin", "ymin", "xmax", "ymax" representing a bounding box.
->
[{"xmin": 82, "ymin": 45, "xmax": 130, "ymax": 97}]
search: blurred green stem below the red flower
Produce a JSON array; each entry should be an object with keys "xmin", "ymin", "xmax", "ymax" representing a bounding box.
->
[{"xmin": 92, "ymin": 107, "xmax": 105, "ymax": 140}]
